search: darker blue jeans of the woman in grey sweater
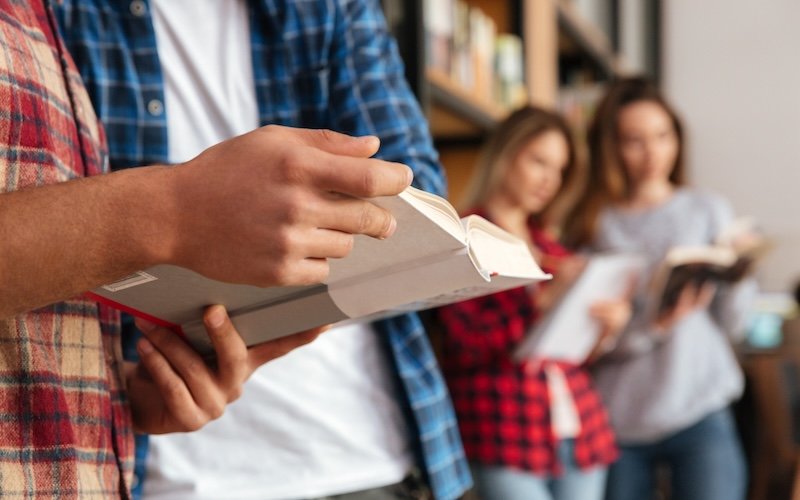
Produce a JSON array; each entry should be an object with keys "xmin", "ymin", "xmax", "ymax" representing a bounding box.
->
[{"xmin": 606, "ymin": 409, "xmax": 747, "ymax": 500}]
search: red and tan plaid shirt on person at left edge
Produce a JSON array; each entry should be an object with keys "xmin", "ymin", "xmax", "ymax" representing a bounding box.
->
[{"xmin": 0, "ymin": 0, "xmax": 133, "ymax": 499}]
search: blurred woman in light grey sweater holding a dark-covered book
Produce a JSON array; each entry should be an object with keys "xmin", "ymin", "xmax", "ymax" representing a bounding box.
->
[{"xmin": 567, "ymin": 78, "xmax": 755, "ymax": 500}]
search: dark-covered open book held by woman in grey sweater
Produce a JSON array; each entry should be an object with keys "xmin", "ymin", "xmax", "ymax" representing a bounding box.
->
[{"xmin": 651, "ymin": 218, "xmax": 772, "ymax": 317}]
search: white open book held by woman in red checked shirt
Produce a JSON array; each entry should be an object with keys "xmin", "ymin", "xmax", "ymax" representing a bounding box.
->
[{"xmin": 514, "ymin": 253, "xmax": 646, "ymax": 364}]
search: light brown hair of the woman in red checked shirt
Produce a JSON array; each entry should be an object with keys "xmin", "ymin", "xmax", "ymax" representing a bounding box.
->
[{"xmin": 461, "ymin": 106, "xmax": 580, "ymax": 224}]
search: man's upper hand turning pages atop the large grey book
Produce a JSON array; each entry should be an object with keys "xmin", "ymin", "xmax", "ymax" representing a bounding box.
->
[{"xmin": 165, "ymin": 126, "xmax": 412, "ymax": 286}]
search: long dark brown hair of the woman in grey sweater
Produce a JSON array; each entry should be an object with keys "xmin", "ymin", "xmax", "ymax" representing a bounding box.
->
[{"xmin": 565, "ymin": 77, "xmax": 686, "ymax": 247}]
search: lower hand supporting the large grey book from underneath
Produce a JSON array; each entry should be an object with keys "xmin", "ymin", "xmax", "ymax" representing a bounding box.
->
[{"xmin": 126, "ymin": 306, "xmax": 323, "ymax": 434}]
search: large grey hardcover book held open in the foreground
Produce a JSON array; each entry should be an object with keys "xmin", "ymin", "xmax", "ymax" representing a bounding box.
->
[{"xmin": 91, "ymin": 188, "xmax": 550, "ymax": 352}]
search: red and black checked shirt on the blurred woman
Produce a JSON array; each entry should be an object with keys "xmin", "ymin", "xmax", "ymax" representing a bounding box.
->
[{"xmin": 437, "ymin": 212, "xmax": 618, "ymax": 475}]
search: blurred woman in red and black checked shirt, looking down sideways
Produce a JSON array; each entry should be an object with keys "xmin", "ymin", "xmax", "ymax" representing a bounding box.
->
[{"xmin": 438, "ymin": 107, "xmax": 630, "ymax": 500}]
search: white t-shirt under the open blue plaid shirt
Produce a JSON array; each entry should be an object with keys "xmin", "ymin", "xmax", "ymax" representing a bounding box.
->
[{"xmin": 144, "ymin": 0, "xmax": 413, "ymax": 499}]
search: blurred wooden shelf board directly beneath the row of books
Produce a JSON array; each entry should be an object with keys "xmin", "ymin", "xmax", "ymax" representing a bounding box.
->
[{"xmin": 425, "ymin": 68, "xmax": 508, "ymax": 139}]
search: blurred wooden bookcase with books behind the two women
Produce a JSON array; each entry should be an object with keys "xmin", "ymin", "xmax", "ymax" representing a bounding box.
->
[{"xmin": 383, "ymin": 0, "xmax": 659, "ymax": 204}]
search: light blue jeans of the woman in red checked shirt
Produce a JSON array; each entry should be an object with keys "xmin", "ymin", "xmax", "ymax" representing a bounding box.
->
[{"xmin": 472, "ymin": 439, "xmax": 607, "ymax": 500}]
